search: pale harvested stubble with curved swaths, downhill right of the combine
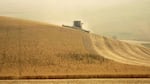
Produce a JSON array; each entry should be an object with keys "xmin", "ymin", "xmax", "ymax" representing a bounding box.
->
[{"xmin": 90, "ymin": 34, "xmax": 150, "ymax": 66}]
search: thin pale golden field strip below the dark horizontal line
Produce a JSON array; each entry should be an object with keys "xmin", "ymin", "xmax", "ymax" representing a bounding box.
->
[{"xmin": 0, "ymin": 78, "xmax": 150, "ymax": 84}]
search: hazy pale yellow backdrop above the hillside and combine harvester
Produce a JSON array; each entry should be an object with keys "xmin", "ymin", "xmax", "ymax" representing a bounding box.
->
[{"xmin": 0, "ymin": 0, "xmax": 150, "ymax": 40}]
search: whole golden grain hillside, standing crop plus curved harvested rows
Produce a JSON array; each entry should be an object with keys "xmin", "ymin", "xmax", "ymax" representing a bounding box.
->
[{"xmin": 0, "ymin": 17, "xmax": 150, "ymax": 78}]
